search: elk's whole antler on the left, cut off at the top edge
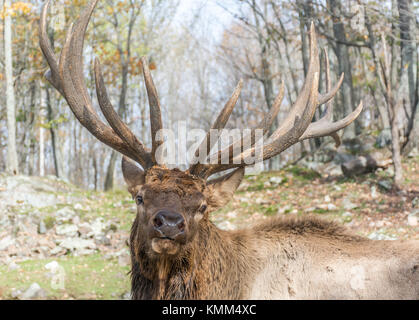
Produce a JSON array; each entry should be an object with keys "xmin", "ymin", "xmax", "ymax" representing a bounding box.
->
[{"xmin": 39, "ymin": 0, "xmax": 162, "ymax": 169}]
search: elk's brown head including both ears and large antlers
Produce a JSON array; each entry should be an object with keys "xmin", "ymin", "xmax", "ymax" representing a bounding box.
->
[{"xmin": 40, "ymin": 0, "xmax": 362, "ymax": 256}]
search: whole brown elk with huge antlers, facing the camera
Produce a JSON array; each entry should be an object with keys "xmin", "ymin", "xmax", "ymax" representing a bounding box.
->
[{"xmin": 39, "ymin": 0, "xmax": 419, "ymax": 299}]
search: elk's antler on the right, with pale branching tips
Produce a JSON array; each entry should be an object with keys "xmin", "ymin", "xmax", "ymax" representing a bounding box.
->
[{"xmin": 189, "ymin": 23, "xmax": 363, "ymax": 179}]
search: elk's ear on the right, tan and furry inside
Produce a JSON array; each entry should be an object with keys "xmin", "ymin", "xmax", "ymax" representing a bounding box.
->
[{"xmin": 208, "ymin": 168, "xmax": 244, "ymax": 210}]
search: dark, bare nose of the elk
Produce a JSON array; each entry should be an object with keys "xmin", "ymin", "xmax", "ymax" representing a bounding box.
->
[{"xmin": 153, "ymin": 210, "xmax": 185, "ymax": 239}]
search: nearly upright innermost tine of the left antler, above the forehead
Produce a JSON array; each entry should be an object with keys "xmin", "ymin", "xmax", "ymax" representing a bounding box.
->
[{"xmin": 141, "ymin": 57, "xmax": 163, "ymax": 163}]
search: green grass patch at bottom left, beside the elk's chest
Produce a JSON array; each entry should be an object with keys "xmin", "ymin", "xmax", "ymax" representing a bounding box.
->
[{"xmin": 0, "ymin": 254, "xmax": 129, "ymax": 299}]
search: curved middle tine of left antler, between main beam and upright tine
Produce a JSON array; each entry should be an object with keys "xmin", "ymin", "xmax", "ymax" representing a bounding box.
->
[{"xmin": 94, "ymin": 59, "xmax": 153, "ymax": 168}]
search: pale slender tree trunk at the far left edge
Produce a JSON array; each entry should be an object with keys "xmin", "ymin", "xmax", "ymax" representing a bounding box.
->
[{"xmin": 4, "ymin": 0, "xmax": 19, "ymax": 175}]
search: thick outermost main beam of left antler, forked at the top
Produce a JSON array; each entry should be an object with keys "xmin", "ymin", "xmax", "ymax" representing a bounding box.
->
[{"xmin": 39, "ymin": 0, "xmax": 153, "ymax": 166}]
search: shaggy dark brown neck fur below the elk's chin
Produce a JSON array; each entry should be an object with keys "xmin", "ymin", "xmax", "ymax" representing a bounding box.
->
[{"xmin": 131, "ymin": 222, "xmax": 256, "ymax": 299}]
